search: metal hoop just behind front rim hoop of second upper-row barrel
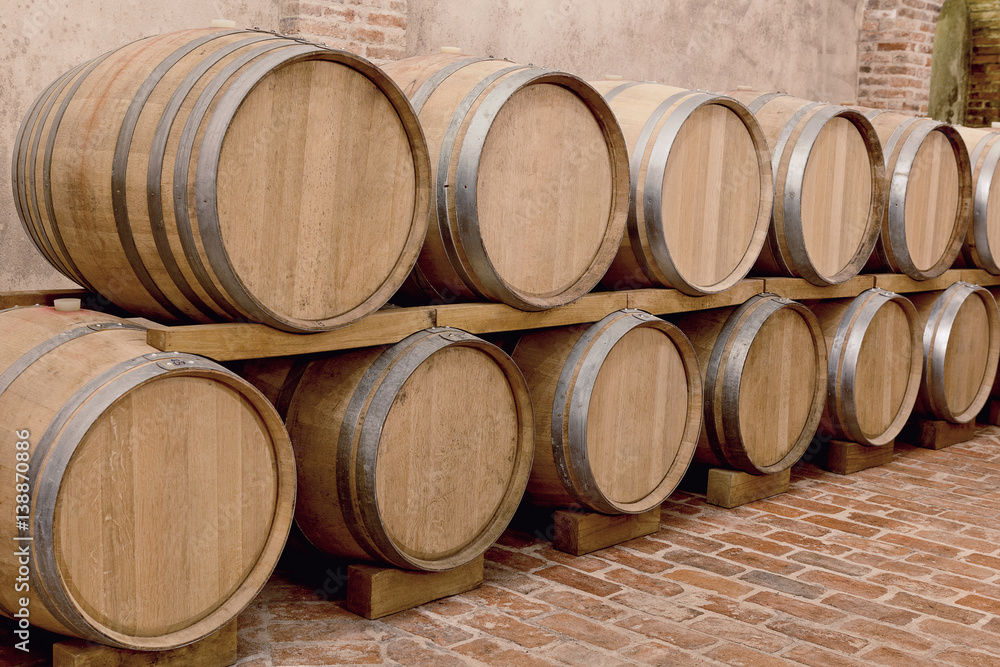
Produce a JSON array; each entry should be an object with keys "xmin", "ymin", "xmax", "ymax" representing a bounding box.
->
[{"xmin": 434, "ymin": 65, "xmax": 527, "ymax": 299}]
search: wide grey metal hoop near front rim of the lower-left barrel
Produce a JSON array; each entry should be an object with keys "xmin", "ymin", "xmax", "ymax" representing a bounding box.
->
[{"xmin": 29, "ymin": 352, "xmax": 225, "ymax": 648}]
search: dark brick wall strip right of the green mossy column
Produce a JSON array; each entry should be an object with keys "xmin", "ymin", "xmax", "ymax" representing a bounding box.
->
[{"xmin": 965, "ymin": 0, "xmax": 1000, "ymax": 126}]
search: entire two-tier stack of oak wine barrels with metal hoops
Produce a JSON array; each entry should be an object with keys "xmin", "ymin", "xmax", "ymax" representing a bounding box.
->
[{"xmin": 0, "ymin": 30, "xmax": 1000, "ymax": 649}]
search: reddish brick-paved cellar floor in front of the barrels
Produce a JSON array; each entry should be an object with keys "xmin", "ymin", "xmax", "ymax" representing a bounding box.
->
[{"xmin": 9, "ymin": 427, "xmax": 1000, "ymax": 667}]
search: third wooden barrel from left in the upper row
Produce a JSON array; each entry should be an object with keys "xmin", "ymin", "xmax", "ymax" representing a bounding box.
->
[{"xmin": 591, "ymin": 81, "xmax": 774, "ymax": 296}]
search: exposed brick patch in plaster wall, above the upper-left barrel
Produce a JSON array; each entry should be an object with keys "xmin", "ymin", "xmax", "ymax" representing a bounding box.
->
[{"xmin": 280, "ymin": 0, "xmax": 407, "ymax": 62}]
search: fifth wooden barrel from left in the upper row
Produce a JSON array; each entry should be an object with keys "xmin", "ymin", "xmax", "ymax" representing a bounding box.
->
[{"xmin": 865, "ymin": 109, "xmax": 972, "ymax": 280}]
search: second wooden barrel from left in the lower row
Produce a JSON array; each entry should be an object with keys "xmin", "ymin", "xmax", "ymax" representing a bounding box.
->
[{"xmin": 241, "ymin": 328, "xmax": 533, "ymax": 571}]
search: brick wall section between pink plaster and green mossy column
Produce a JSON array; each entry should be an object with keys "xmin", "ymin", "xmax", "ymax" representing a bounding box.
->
[{"xmin": 858, "ymin": 0, "xmax": 943, "ymax": 114}]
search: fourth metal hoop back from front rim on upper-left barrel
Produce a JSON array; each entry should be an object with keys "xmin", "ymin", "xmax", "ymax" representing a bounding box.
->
[{"xmin": 111, "ymin": 30, "xmax": 239, "ymax": 320}]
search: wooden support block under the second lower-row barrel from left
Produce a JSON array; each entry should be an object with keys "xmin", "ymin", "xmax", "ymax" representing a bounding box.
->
[{"xmin": 347, "ymin": 556, "xmax": 484, "ymax": 619}]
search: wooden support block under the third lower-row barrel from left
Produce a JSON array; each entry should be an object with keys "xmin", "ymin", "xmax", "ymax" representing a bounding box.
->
[{"xmin": 552, "ymin": 507, "xmax": 660, "ymax": 556}]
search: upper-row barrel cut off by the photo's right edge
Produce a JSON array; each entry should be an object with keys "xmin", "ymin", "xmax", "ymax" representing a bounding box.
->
[{"xmin": 955, "ymin": 126, "xmax": 1000, "ymax": 274}]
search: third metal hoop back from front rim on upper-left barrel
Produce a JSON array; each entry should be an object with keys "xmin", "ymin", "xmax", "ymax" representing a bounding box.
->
[{"xmin": 146, "ymin": 34, "xmax": 279, "ymax": 320}]
